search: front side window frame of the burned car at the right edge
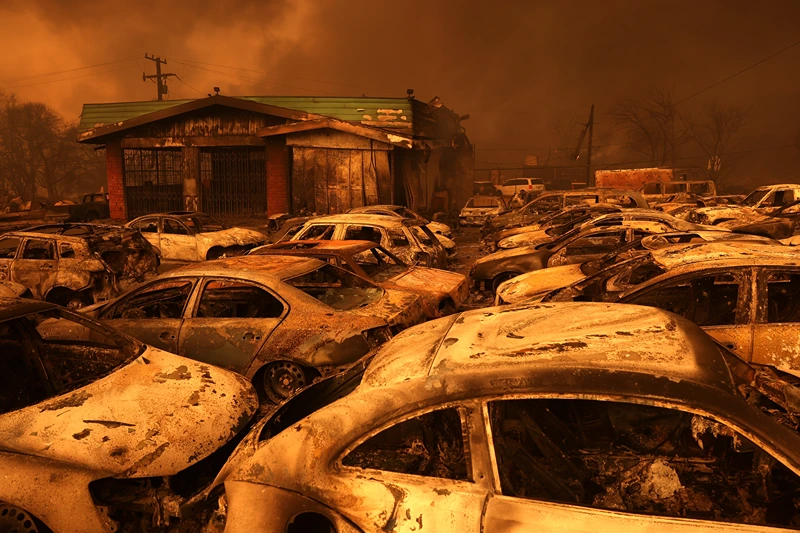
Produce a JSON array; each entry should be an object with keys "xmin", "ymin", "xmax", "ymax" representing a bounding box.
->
[{"xmin": 617, "ymin": 266, "xmax": 756, "ymax": 329}]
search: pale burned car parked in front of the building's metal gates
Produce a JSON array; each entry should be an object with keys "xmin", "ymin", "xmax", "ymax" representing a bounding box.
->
[{"xmin": 125, "ymin": 211, "xmax": 267, "ymax": 261}]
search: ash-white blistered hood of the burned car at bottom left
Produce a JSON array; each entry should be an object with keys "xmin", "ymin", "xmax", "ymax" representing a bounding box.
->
[{"xmin": 0, "ymin": 347, "xmax": 258, "ymax": 477}]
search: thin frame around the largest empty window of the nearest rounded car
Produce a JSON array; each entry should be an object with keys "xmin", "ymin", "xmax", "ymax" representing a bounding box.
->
[{"xmin": 482, "ymin": 393, "xmax": 800, "ymax": 530}]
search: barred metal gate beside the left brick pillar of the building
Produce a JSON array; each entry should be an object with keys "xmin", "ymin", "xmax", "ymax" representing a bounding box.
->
[{"xmin": 122, "ymin": 148, "xmax": 183, "ymax": 219}]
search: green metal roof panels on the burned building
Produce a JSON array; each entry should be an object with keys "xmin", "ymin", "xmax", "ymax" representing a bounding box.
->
[{"xmin": 79, "ymin": 96, "xmax": 413, "ymax": 132}]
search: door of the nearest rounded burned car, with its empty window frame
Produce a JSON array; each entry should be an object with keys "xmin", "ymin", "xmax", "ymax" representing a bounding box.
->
[{"xmin": 480, "ymin": 392, "xmax": 800, "ymax": 533}]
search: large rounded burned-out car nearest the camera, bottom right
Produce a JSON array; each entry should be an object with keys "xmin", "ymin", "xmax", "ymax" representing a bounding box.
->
[{"xmin": 216, "ymin": 304, "xmax": 800, "ymax": 533}]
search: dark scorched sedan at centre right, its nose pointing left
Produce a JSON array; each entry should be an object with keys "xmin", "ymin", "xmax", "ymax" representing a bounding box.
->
[{"xmin": 469, "ymin": 220, "xmax": 672, "ymax": 291}]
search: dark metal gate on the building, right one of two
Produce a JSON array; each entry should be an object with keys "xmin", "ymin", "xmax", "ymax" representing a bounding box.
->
[{"xmin": 200, "ymin": 148, "xmax": 267, "ymax": 219}]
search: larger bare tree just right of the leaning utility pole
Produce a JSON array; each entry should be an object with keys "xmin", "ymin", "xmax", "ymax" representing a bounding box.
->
[{"xmin": 610, "ymin": 90, "xmax": 686, "ymax": 166}]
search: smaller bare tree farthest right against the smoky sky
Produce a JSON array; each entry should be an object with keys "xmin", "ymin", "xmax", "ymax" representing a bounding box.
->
[{"xmin": 683, "ymin": 103, "xmax": 747, "ymax": 185}]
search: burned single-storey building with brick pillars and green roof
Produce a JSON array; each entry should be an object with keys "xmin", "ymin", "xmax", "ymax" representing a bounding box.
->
[{"xmin": 78, "ymin": 95, "xmax": 473, "ymax": 219}]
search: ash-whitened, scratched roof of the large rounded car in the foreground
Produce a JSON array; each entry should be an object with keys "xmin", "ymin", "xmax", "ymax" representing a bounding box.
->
[{"xmin": 362, "ymin": 303, "xmax": 734, "ymax": 392}]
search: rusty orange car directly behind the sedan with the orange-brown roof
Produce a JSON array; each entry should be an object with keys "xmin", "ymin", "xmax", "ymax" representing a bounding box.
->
[{"xmin": 248, "ymin": 241, "xmax": 469, "ymax": 318}]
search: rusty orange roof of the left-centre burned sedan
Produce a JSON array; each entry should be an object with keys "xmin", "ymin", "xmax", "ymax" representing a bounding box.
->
[{"xmin": 162, "ymin": 255, "xmax": 325, "ymax": 280}]
